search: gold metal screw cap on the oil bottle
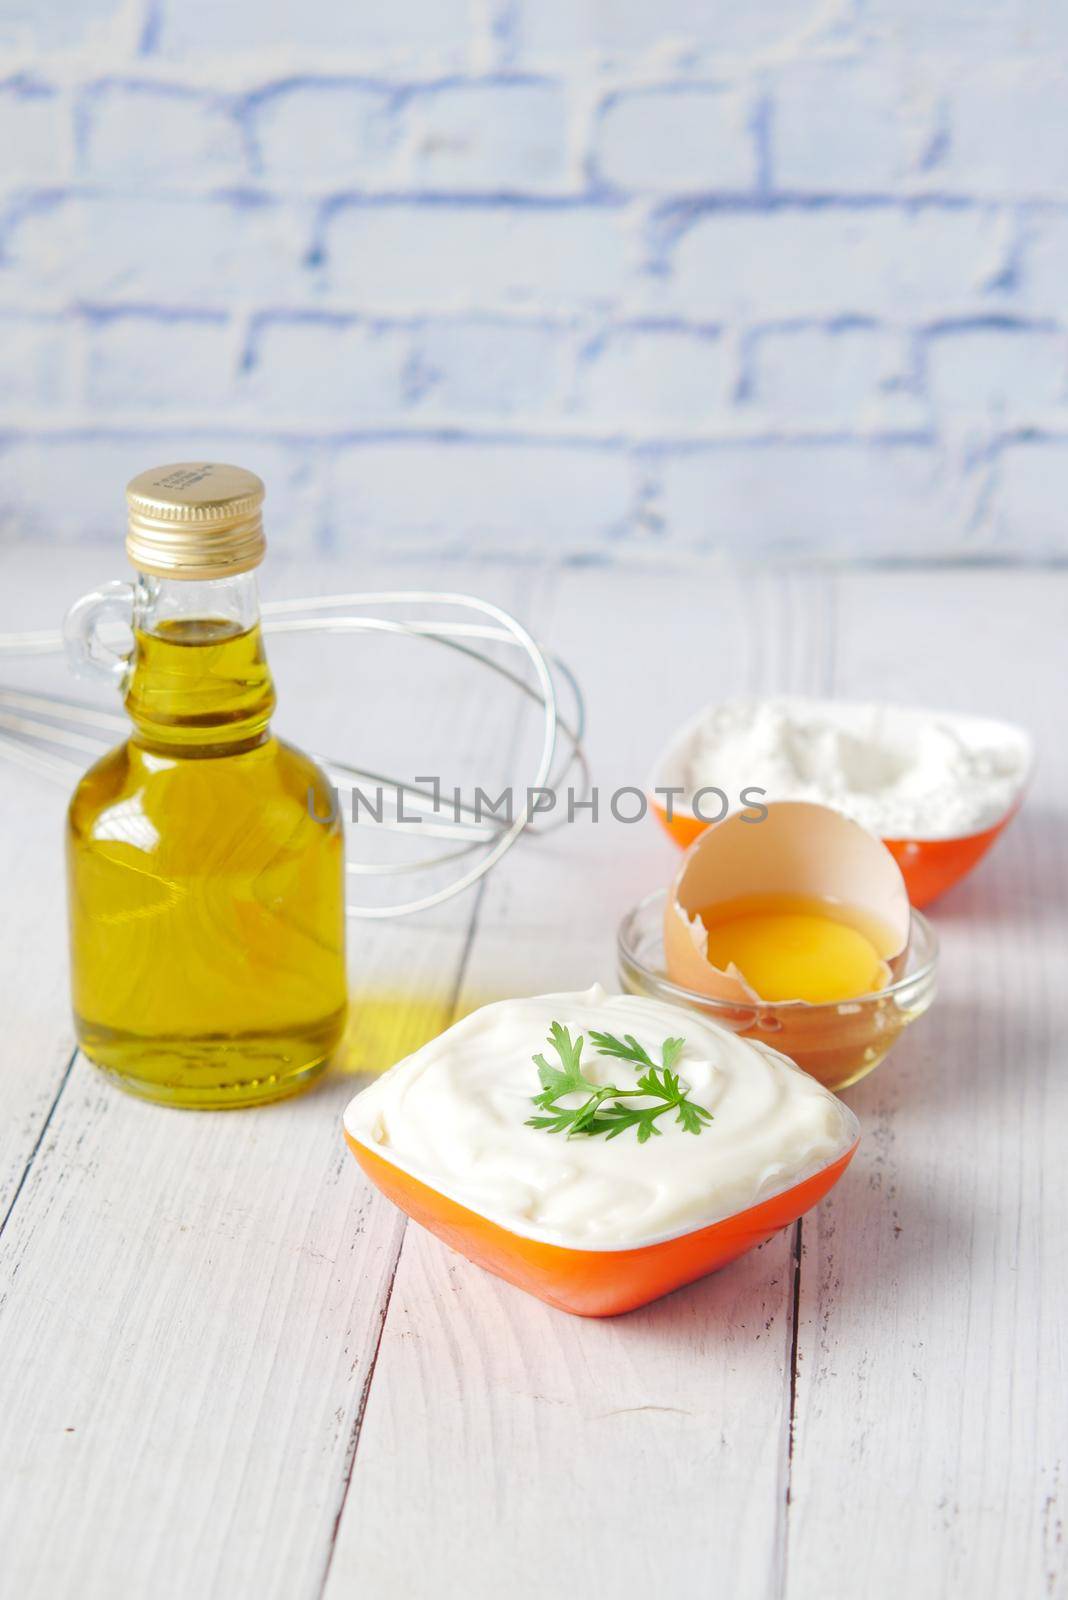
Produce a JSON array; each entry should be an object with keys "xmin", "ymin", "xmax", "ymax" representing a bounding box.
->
[{"xmin": 126, "ymin": 461, "xmax": 267, "ymax": 578}]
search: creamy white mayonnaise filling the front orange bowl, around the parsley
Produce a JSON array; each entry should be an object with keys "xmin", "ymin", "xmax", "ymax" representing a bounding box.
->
[{"xmin": 345, "ymin": 986, "xmax": 857, "ymax": 1250}]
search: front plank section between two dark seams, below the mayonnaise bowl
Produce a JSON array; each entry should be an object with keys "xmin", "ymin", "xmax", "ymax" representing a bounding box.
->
[{"xmin": 326, "ymin": 1209, "xmax": 790, "ymax": 1600}]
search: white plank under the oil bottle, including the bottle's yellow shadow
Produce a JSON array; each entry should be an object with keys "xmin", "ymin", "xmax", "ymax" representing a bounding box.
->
[{"xmin": 0, "ymin": 553, "xmax": 530, "ymax": 1600}]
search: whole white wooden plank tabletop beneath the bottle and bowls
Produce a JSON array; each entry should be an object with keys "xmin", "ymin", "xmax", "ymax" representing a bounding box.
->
[{"xmin": 0, "ymin": 549, "xmax": 1068, "ymax": 1600}]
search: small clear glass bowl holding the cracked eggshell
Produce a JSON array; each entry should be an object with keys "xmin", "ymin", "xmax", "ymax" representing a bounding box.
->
[{"xmin": 617, "ymin": 890, "xmax": 938, "ymax": 1090}]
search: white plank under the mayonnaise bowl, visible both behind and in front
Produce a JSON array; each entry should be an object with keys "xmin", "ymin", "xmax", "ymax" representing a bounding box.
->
[{"xmin": 326, "ymin": 571, "xmax": 828, "ymax": 1600}]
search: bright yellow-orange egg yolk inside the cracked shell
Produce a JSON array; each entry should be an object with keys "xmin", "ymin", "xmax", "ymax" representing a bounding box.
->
[{"xmin": 702, "ymin": 894, "xmax": 887, "ymax": 1005}]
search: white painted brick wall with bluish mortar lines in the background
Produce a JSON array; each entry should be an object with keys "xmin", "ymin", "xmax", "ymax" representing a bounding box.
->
[{"xmin": 0, "ymin": 0, "xmax": 1068, "ymax": 560}]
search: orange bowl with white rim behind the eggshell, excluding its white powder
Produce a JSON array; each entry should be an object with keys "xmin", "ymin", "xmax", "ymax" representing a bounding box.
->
[{"xmin": 648, "ymin": 707, "xmax": 1034, "ymax": 907}]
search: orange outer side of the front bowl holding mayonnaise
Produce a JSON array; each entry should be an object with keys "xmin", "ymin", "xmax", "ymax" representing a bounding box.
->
[{"xmin": 345, "ymin": 1107, "xmax": 860, "ymax": 1317}]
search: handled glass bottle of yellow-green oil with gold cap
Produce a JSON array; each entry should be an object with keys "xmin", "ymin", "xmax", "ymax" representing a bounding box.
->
[{"xmin": 67, "ymin": 464, "xmax": 345, "ymax": 1107}]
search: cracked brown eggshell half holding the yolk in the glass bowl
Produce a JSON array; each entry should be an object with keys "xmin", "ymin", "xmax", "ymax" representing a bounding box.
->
[{"xmin": 664, "ymin": 800, "xmax": 910, "ymax": 1003}]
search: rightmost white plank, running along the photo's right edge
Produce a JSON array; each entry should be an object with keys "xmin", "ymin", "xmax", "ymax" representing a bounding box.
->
[{"xmin": 787, "ymin": 573, "xmax": 1068, "ymax": 1600}]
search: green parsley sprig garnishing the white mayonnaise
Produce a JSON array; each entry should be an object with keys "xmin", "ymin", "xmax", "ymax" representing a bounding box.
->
[{"xmin": 526, "ymin": 1022, "xmax": 711, "ymax": 1144}]
